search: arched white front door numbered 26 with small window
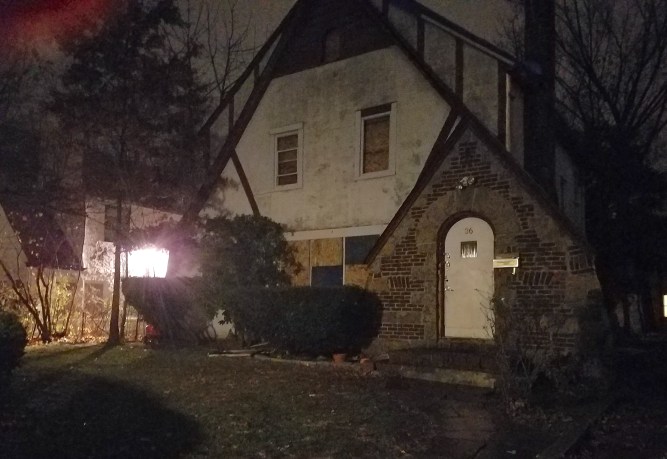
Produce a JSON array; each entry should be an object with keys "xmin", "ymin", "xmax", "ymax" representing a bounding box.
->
[{"xmin": 444, "ymin": 217, "xmax": 493, "ymax": 339}]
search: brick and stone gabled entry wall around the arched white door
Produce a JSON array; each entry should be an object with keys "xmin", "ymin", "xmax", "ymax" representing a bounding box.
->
[{"xmin": 371, "ymin": 129, "xmax": 599, "ymax": 351}]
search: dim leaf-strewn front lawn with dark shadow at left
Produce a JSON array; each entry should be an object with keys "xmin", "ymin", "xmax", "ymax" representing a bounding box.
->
[{"xmin": 0, "ymin": 345, "xmax": 512, "ymax": 458}]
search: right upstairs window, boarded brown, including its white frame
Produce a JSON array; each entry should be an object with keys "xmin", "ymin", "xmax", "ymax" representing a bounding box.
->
[{"xmin": 358, "ymin": 103, "xmax": 396, "ymax": 178}]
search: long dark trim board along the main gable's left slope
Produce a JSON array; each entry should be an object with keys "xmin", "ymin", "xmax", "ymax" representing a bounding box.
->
[{"xmin": 181, "ymin": 0, "xmax": 307, "ymax": 225}]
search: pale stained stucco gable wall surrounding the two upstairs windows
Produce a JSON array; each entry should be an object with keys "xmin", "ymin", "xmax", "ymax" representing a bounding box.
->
[{"xmin": 209, "ymin": 47, "xmax": 449, "ymax": 231}]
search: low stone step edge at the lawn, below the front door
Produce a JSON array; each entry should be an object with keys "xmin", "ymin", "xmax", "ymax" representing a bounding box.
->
[{"xmin": 377, "ymin": 363, "xmax": 496, "ymax": 389}]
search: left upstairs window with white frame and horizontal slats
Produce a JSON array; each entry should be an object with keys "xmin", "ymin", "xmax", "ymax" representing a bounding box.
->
[{"xmin": 271, "ymin": 124, "xmax": 303, "ymax": 189}]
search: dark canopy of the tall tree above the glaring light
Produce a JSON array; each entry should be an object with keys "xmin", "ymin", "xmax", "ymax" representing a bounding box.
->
[{"xmin": 50, "ymin": 0, "xmax": 206, "ymax": 210}]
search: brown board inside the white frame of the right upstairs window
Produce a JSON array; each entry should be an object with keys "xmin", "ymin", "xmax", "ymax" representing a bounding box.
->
[{"xmin": 361, "ymin": 113, "xmax": 390, "ymax": 174}]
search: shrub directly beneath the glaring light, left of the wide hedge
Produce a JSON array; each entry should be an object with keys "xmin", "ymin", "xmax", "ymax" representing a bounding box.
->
[{"xmin": 123, "ymin": 277, "xmax": 208, "ymax": 344}]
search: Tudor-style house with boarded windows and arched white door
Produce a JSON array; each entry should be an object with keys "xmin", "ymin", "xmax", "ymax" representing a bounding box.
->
[{"xmin": 184, "ymin": 0, "xmax": 599, "ymax": 352}]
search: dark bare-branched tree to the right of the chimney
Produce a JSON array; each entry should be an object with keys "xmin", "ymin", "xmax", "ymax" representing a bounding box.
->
[{"xmin": 505, "ymin": 0, "xmax": 667, "ymax": 326}]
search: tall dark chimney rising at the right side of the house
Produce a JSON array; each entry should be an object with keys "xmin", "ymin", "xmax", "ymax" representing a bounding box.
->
[{"xmin": 524, "ymin": 0, "xmax": 556, "ymax": 198}]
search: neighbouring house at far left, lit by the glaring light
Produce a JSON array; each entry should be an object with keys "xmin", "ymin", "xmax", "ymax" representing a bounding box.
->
[{"xmin": 0, "ymin": 191, "xmax": 180, "ymax": 338}]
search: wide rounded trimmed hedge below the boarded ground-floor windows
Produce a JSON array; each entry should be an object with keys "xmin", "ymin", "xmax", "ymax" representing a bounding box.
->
[{"xmin": 222, "ymin": 286, "xmax": 382, "ymax": 356}]
